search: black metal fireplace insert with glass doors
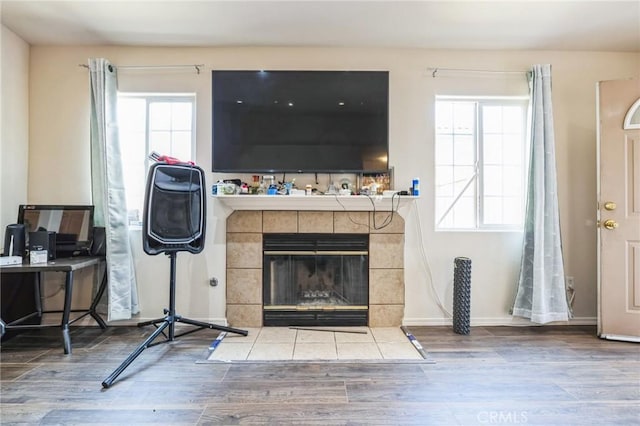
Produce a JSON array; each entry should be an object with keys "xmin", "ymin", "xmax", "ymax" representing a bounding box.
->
[{"xmin": 262, "ymin": 234, "xmax": 369, "ymax": 326}]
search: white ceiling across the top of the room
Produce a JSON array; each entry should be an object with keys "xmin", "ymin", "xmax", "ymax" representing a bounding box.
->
[{"xmin": 1, "ymin": 0, "xmax": 640, "ymax": 52}]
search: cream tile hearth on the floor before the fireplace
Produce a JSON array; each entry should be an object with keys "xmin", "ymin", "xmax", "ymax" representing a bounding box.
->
[{"xmin": 208, "ymin": 327, "xmax": 423, "ymax": 361}]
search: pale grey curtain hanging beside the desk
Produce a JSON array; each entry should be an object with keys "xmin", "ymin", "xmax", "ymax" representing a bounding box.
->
[{"xmin": 89, "ymin": 58, "xmax": 139, "ymax": 321}]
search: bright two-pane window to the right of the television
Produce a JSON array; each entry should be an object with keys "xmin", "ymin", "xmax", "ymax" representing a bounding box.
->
[{"xmin": 435, "ymin": 97, "xmax": 528, "ymax": 229}]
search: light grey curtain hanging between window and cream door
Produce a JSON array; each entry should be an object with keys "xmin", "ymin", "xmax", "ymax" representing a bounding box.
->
[{"xmin": 513, "ymin": 64, "xmax": 569, "ymax": 324}]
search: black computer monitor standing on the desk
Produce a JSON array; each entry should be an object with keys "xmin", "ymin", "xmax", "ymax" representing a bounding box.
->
[{"xmin": 18, "ymin": 204, "xmax": 94, "ymax": 257}]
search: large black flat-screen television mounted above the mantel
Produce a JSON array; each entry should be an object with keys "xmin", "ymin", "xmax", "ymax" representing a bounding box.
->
[{"xmin": 212, "ymin": 70, "xmax": 389, "ymax": 173}]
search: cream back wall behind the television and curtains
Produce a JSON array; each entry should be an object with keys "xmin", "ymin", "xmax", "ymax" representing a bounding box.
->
[{"xmin": 22, "ymin": 46, "xmax": 640, "ymax": 324}]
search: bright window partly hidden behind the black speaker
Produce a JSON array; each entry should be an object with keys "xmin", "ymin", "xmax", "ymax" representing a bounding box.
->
[{"xmin": 118, "ymin": 93, "xmax": 195, "ymax": 225}]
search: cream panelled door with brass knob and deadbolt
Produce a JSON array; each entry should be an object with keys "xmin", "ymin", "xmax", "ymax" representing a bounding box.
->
[{"xmin": 598, "ymin": 79, "xmax": 640, "ymax": 341}]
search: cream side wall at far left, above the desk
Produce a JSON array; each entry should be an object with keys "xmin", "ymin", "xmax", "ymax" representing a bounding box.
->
[{"xmin": 0, "ymin": 25, "xmax": 29, "ymax": 246}]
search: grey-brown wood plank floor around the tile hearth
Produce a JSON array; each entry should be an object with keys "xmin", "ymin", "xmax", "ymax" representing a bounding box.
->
[{"xmin": 0, "ymin": 326, "xmax": 640, "ymax": 426}]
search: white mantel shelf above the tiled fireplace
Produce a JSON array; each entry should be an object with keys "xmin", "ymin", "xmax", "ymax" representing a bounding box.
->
[{"xmin": 214, "ymin": 195, "xmax": 417, "ymax": 211}]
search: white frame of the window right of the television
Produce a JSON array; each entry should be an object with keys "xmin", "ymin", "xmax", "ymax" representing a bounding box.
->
[{"xmin": 434, "ymin": 96, "xmax": 530, "ymax": 232}]
